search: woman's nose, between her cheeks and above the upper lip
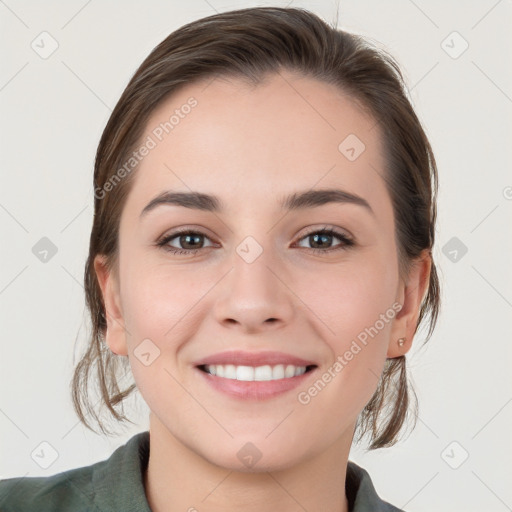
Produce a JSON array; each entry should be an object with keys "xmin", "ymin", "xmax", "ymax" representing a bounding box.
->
[{"xmin": 214, "ymin": 242, "xmax": 294, "ymax": 334}]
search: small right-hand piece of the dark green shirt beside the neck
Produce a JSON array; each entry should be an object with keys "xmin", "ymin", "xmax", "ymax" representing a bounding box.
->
[{"xmin": 345, "ymin": 461, "xmax": 406, "ymax": 512}]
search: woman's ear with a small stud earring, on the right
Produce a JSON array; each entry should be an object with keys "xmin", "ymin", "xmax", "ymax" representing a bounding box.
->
[{"xmin": 387, "ymin": 249, "xmax": 432, "ymax": 358}]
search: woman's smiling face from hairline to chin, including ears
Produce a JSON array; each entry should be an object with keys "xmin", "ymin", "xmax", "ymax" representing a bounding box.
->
[{"xmin": 96, "ymin": 73, "xmax": 423, "ymax": 470}]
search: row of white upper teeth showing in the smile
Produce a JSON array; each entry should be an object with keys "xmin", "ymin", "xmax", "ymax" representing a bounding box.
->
[{"xmin": 205, "ymin": 364, "xmax": 306, "ymax": 381}]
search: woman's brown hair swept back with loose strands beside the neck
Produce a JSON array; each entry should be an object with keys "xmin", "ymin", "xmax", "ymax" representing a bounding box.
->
[{"xmin": 72, "ymin": 7, "xmax": 440, "ymax": 449}]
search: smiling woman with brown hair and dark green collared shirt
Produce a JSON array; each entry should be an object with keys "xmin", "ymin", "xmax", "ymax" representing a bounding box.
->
[{"xmin": 0, "ymin": 8, "xmax": 439, "ymax": 512}]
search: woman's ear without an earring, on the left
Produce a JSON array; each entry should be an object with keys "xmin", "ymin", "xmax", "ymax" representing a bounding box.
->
[{"xmin": 94, "ymin": 254, "xmax": 128, "ymax": 356}]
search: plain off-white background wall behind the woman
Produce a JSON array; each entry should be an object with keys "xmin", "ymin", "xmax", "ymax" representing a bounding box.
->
[{"xmin": 0, "ymin": 0, "xmax": 512, "ymax": 512}]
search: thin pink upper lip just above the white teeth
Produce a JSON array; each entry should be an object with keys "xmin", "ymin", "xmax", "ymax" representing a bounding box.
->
[{"xmin": 195, "ymin": 350, "xmax": 316, "ymax": 367}]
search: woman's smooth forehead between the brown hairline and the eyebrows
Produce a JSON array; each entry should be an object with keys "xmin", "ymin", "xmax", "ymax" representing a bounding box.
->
[{"xmin": 124, "ymin": 72, "xmax": 386, "ymax": 216}]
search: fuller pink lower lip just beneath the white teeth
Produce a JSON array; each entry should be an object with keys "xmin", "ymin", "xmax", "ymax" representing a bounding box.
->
[{"xmin": 196, "ymin": 367, "xmax": 316, "ymax": 400}]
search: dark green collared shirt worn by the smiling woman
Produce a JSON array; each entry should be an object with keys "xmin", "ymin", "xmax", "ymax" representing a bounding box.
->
[{"xmin": 0, "ymin": 431, "xmax": 404, "ymax": 512}]
